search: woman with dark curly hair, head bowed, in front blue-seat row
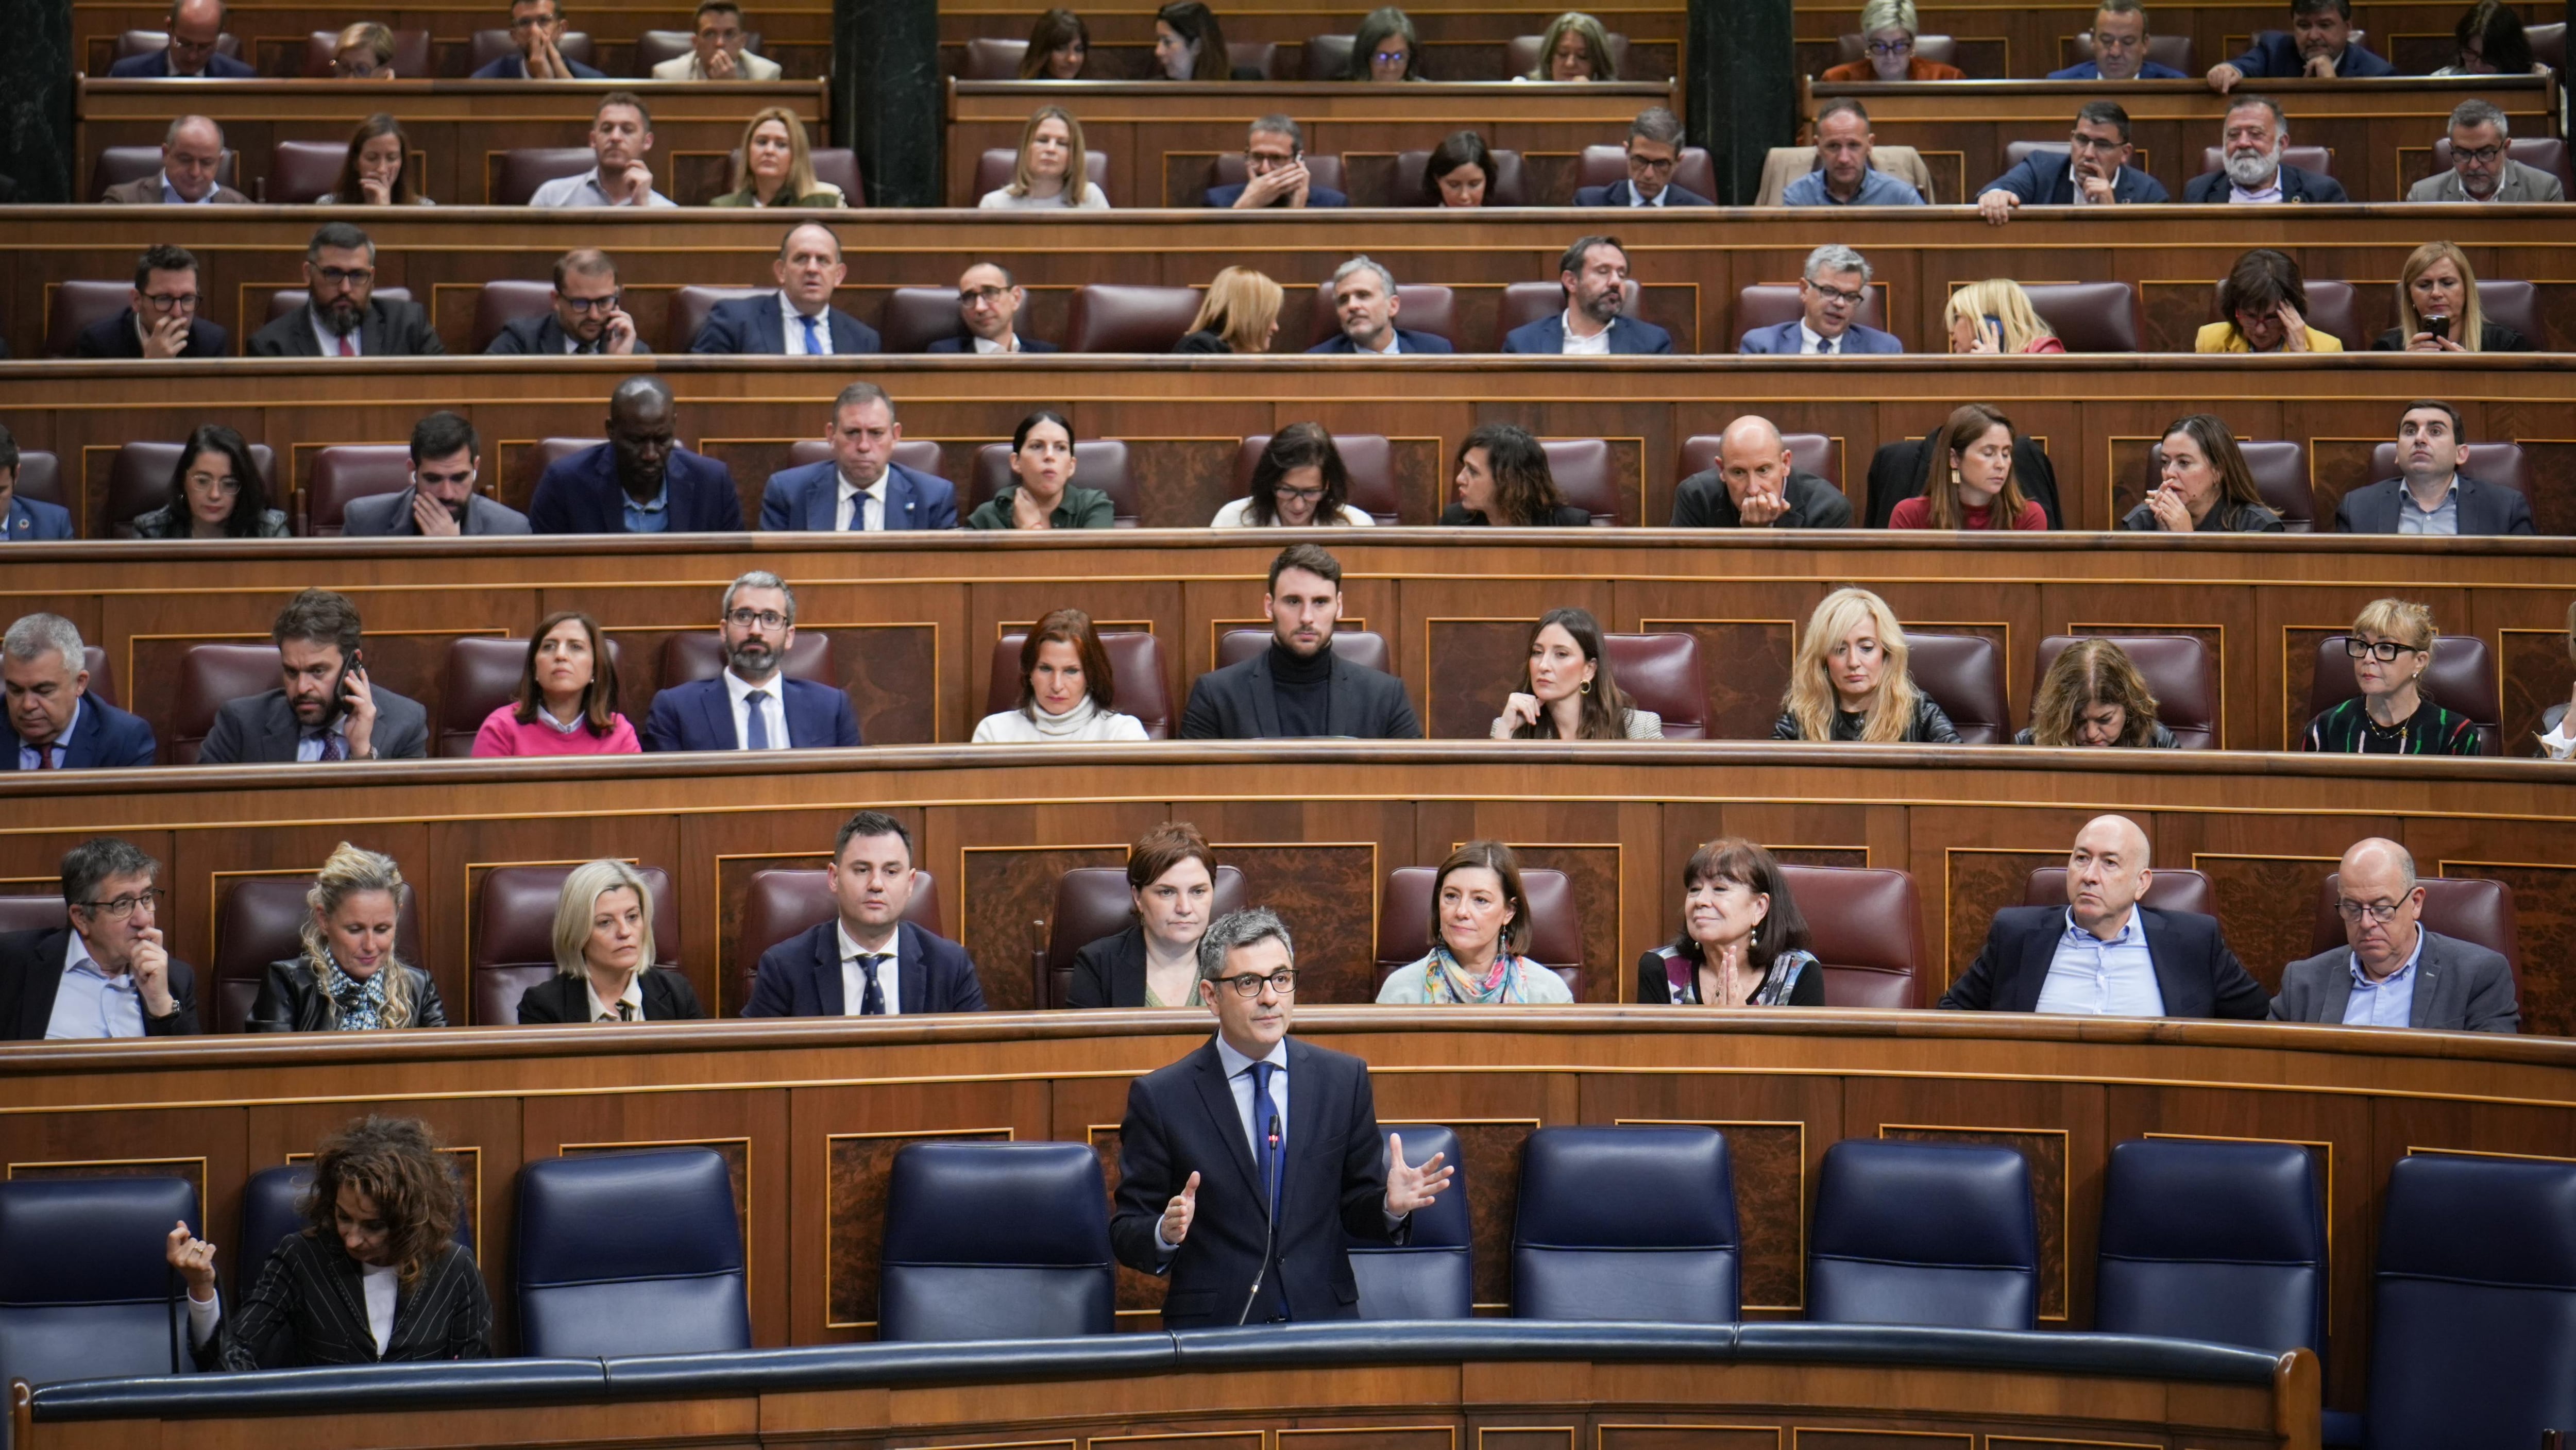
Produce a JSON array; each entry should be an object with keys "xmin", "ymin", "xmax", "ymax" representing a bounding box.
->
[{"xmin": 167, "ymin": 1118, "xmax": 492, "ymax": 1370}]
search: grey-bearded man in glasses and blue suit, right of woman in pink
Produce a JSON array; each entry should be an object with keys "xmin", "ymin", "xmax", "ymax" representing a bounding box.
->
[{"xmin": 644, "ymin": 569, "xmax": 860, "ymax": 747}]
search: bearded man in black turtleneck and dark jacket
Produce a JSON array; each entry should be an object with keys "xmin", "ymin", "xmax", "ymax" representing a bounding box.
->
[{"xmin": 1180, "ymin": 544, "xmax": 1422, "ymax": 739}]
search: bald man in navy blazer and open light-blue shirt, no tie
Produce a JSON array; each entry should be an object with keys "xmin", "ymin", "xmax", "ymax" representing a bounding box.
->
[{"xmin": 1940, "ymin": 816, "xmax": 2272, "ymax": 1020}]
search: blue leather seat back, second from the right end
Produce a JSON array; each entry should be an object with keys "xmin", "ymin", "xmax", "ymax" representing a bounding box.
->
[{"xmin": 2094, "ymin": 1138, "xmax": 2326, "ymax": 1355}]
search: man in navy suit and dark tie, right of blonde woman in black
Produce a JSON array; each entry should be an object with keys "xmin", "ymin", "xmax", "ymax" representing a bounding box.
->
[{"xmin": 742, "ymin": 811, "xmax": 984, "ymax": 1017}]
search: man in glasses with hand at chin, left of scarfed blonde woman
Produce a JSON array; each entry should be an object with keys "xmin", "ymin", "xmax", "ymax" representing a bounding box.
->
[{"xmin": 0, "ymin": 837, "xmax": 206, "ymax": 1043}]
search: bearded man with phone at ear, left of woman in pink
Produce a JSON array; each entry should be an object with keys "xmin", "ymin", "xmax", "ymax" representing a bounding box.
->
[{"xmin": 196, "ymin": 590, "xmax": 430, "ymax": 765}]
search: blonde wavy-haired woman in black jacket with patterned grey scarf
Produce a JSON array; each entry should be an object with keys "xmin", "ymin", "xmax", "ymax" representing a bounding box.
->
[{"xmin": 245, "ymin": 842, "xmax": 448, "ymax": 1033}]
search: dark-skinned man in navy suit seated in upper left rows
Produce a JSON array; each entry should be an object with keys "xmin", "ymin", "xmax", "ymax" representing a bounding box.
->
[{"xmin": 528, "ymin": 376, "xmax": 742, "ymax": 533}]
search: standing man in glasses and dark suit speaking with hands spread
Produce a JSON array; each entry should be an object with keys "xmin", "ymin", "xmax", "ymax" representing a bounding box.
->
[{"xmin": 1110, "ymin": 906, "xmax": 1453, "ymax": 1329}]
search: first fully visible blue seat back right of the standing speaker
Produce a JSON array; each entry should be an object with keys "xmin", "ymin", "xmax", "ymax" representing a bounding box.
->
[{"xmin": 1512, "ymin": 1128, "xmax": 1741, "ymax": 1324}]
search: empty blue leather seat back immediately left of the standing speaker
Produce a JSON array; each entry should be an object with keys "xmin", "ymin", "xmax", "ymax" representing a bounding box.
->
[{"xmin": 876, "ymin": 1143, "xmax": 1118, "ymax": 1339}]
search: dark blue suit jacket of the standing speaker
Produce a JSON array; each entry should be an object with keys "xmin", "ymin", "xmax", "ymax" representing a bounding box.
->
[{"xmin": 1110, "ymin": 1038, "xmax": 1401, "ymax": 1329}]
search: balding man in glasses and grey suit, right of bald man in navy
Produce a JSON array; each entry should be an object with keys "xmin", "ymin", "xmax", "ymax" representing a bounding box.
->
[{"xmin": 2272, "ymin": 837, "xmax": 2522, "ymax": 1033}]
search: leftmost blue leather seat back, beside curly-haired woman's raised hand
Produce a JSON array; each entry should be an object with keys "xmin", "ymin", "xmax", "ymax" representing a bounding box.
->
[{"xmin": 0, "ymin": 1177, "xmax": 206, "ymax": 1411}]
